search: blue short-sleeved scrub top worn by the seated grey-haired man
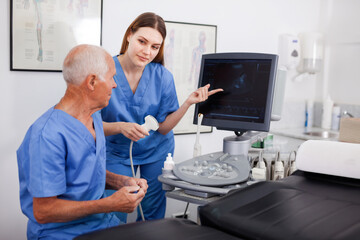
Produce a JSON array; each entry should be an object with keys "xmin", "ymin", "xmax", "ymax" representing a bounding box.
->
[{"xmin": 17, "ymin": 107, "xmax": 119, "ymax": 239}]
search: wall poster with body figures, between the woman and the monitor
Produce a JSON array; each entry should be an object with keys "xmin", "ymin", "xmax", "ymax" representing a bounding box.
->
[{"xmin": 164, "ymin": 21, "xmax": 217, "ymax": 134}]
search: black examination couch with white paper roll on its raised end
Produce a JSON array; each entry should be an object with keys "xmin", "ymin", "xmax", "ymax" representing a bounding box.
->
[{"xmin": 76, "ymin": 141, "xmax": 360, "ymax": 240}]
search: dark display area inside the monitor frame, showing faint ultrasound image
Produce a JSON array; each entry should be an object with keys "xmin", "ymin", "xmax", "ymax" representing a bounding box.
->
[{"xmin": 199, "ymin": 59, "xmax": 271, "ymax": 123}]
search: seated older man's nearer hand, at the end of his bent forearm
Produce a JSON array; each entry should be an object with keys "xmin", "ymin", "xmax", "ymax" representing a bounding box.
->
[{"xmin": 108, "ymin": 186, "xmax": 145, "ymax": 213}]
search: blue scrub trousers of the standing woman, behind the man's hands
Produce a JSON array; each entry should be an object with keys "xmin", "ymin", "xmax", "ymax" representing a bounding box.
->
[{"xmin": 105, "ymin": 161, "xmax": 166, "ymax": 223}]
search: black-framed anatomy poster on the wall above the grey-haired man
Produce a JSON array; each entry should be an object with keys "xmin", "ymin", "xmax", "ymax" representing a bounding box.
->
[{"xmin": 10, "ymin": 0, "xmax": 102, "ymax": 71}]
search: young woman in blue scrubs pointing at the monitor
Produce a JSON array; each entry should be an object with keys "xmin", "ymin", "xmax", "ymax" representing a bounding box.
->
[{"xmin": 101, "ymin": 13, "xmax": 222, "ymax": 222}]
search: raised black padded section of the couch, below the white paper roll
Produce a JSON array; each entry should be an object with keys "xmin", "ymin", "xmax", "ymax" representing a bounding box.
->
[{"xmin": 199, "ymin": 171, "xmax": 360, "ymax": 239}]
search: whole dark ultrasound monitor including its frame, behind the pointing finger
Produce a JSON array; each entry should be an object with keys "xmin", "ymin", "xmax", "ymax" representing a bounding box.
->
[{"xmin": 194, "ymin": 53, "xmax": 278, "ymax": 132}]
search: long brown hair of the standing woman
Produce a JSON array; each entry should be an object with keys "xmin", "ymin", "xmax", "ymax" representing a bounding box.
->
[{"xmin": 120, "ymin": 12, "xmax": 166, "ymax": 65}]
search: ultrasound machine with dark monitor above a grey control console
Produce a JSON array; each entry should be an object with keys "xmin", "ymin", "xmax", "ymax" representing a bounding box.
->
[{"xmin": 159, "ymin": 53, "xmax": 278, "ymax": 200}]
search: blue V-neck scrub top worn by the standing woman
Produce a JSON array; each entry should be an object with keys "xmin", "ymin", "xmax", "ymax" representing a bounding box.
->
[{"xmin": 101, "ymin": 56, "xmax": 179, "ymax": 165}]
